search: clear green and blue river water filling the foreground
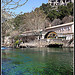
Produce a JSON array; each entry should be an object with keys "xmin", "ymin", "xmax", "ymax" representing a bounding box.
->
[{"xmin": 2, "ymin": 48, "xmax": 73, "ymax": 75}]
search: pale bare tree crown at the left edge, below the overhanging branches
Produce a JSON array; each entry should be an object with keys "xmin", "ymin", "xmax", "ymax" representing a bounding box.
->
[{"xmin": 1, "ymin": 20, "xmax": 14, "ymax": 43}]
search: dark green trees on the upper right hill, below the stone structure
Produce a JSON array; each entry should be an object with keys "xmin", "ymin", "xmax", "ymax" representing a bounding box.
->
[{"xmin": 40, "ymin": 3, "xmax": 73, "ymax": 21}]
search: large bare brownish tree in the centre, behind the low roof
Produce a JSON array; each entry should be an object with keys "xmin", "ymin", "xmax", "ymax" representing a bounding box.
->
[{"xmin": 19, "ymin": 8, "xmax": 49, "ymax": 31}]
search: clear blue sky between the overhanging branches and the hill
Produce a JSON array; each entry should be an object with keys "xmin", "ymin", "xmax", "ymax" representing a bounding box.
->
[{"xmin": 9, "ymin": 0, "xmax": 48, "ymax": 14}]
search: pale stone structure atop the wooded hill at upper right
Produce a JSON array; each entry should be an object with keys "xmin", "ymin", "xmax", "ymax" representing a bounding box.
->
[{"xmin": 48, "ymin": 0, "xmax": 74, "ymax": 6}]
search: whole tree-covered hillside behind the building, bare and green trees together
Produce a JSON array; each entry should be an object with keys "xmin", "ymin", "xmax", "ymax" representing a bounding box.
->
[{"xmin": 2, "ymin": 3, "xmax": 73, "ymax": 35}]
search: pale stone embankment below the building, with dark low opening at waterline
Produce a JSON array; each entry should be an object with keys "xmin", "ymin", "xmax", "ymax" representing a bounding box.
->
[{"xmin": 19, "ymin": 41, "xmax": 74, "ymax": 48}]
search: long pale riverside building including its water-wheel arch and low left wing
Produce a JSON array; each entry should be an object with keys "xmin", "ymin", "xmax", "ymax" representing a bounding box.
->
[{"xmin": 20, "ymin": 22, "xmax": 74, "ymax": 42}]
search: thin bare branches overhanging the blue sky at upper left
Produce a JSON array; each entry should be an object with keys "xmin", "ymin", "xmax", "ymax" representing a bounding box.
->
[{"xmin": 1, "ymin": 0, "xmax": 28, "ymax": 17}]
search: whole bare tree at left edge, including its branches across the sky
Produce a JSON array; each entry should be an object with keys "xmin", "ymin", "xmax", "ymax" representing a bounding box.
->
[{"xmin": 1, "ymin": 0, "xmax": 28, "ymax": 44}]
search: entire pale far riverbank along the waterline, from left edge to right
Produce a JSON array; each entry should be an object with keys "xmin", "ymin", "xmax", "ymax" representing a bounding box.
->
[{"xmin": 2, "ymin": 39, "xmax": 74, "ymax": 48}]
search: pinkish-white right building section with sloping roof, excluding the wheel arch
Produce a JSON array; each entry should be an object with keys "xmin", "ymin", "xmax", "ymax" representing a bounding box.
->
[{"xmin": 42, "ymin": 22, "xmax": 74, "ymax": 40}]
